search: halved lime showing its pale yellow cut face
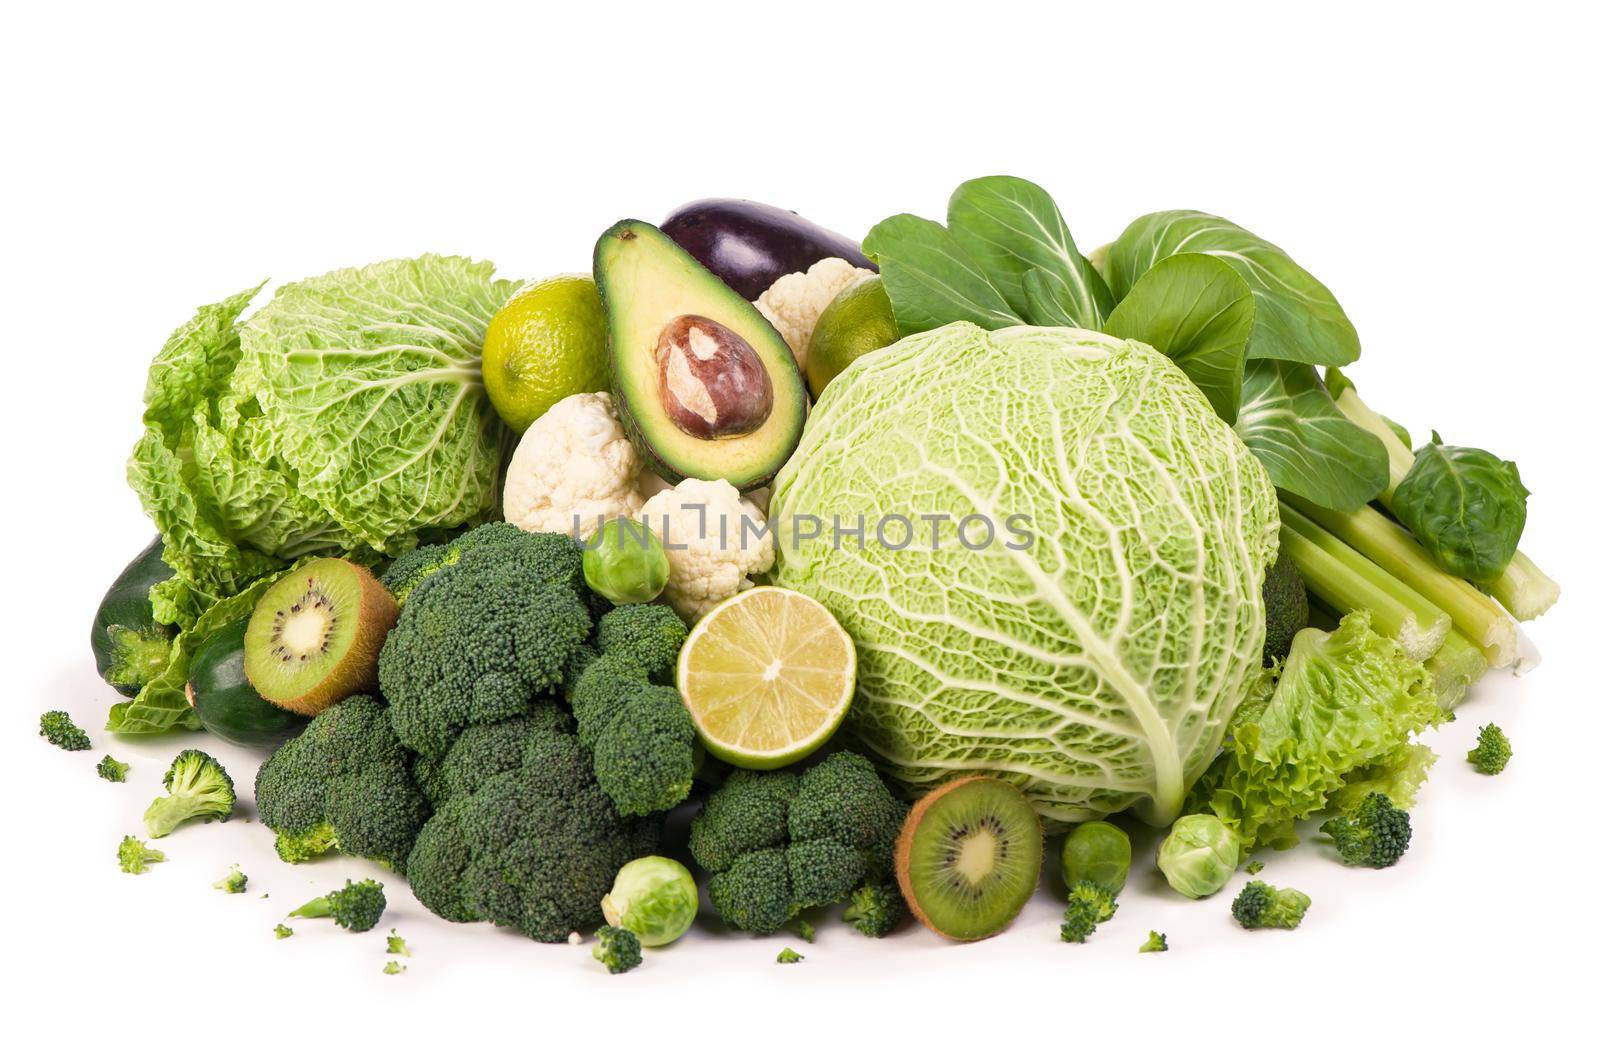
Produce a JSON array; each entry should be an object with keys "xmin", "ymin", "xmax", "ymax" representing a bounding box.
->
[{"xmin": 678, "ymin": 586, "xmax": 856, "ymax": 770}]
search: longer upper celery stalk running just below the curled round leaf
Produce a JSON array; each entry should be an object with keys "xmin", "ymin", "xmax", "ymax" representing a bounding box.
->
[{"xmin": 1278, "ymin": 493, "xmax": 1517, "ymax": 668}]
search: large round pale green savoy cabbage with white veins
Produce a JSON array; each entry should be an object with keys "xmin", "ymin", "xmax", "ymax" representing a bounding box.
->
[{"xmin": 771, "ymin": 323, "xmax": 1278, "ymax": 828}]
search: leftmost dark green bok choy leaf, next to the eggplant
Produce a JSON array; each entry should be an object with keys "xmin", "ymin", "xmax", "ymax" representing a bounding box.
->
[{"xmin": 861, "ymin": 213, "xmax": 1022, "ymax": 335}]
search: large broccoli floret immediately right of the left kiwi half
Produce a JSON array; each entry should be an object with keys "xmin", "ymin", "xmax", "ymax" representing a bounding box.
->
[{"xmin": 378, "ymin": 528, "xmax": 590, "ymax": 759}]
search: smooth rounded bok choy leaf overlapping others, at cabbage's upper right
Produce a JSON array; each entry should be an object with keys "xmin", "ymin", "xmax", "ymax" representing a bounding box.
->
[{"xmin": 1106, "ymin": 253, "xmax": 1256, "ymax": 424}]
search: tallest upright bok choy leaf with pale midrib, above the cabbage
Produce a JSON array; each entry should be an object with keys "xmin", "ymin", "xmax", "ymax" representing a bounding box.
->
[{"xmin": 947, "ymin": 176, "xmax": 1110, "ymax": 330}]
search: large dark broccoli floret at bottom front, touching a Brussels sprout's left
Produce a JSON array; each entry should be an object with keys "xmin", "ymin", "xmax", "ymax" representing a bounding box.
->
[{"xmin": 406, "ymin": 728, "xmax": 659, "ymax": 941}]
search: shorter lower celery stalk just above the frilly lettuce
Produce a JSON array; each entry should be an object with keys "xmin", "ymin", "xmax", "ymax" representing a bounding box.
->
[{"xmin": 1278, "ymin": 507, "xmax": 1450, "ymax": 661}]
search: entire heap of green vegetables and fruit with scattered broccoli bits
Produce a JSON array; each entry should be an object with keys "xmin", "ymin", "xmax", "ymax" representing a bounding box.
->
[{"xmin": 56, "ymin": 176, "xmax": 1560, "ymax": 975}]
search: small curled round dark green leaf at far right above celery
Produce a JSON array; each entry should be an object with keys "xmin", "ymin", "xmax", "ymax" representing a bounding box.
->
[{"xmin": 1390, "ymin": 432, "xmax": 1528, "ymax": 583}]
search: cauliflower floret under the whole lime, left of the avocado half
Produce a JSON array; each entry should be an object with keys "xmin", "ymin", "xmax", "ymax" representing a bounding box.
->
[{"xmin": 502, "ymin": 392, "xmax": 645, "ymax": 538}]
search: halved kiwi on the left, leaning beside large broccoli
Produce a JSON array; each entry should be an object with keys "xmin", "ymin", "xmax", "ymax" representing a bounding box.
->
[{"xmin": 245, "ymin": 557, "xmax": 400, "ymax": 716}]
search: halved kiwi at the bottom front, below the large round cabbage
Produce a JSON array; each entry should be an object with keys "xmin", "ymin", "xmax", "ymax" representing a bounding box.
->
[{"xmin": 894, "ymin": 776, "xmax": 1045, "ymax": 941}]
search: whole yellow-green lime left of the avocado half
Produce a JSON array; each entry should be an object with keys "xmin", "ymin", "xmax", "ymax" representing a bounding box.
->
[{"xmin": 483, "ymin": 275, "xmax": 610, "ymax": 432}]
